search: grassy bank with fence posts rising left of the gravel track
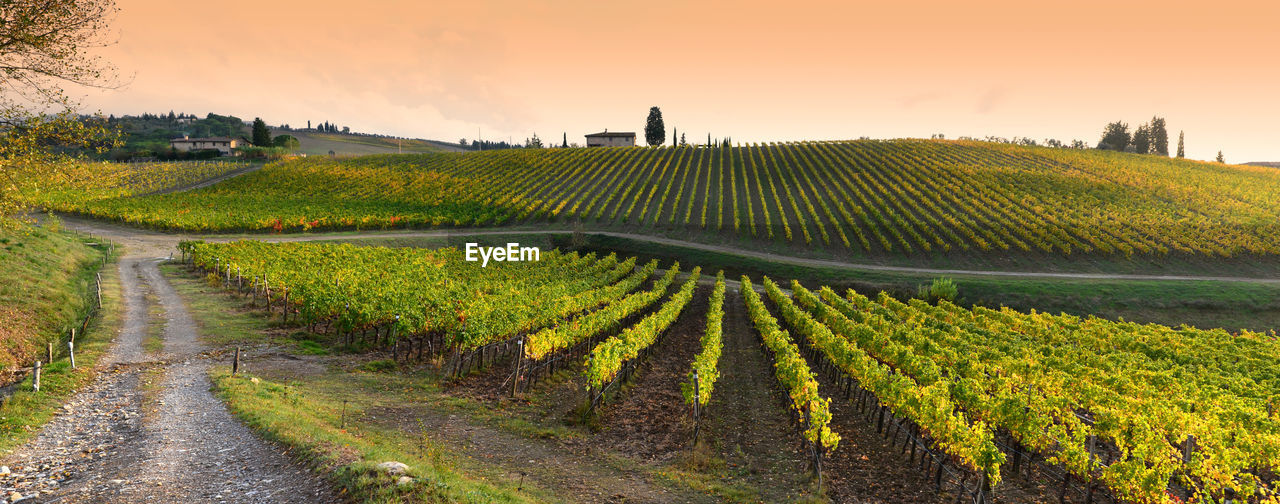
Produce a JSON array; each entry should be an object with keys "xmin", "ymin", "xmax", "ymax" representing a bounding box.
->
[{"xmin": 0, "ymin": 222, "xmax": 122, "ymax": 453}]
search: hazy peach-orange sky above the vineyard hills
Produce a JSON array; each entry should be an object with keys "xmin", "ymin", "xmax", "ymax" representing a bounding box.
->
[{"xmin": 81, "ymin": 0, "xmax": 1280, "ymax": 162}]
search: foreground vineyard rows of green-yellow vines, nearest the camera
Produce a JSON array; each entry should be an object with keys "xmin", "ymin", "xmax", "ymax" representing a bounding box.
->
[{"xmin": 172, "ymin": 242, "xmax": 1280, "ymax": 503}]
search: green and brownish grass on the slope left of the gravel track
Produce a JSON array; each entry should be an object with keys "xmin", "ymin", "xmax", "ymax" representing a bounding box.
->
[{"xmin": 0, "ymin": 230, "xmax": 123, "ymax": 453}]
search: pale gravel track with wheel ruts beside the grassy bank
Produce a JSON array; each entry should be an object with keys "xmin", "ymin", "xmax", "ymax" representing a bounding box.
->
[{"xmin": 0, "ymin": 252, "xmax": 342, "ymax": 504}]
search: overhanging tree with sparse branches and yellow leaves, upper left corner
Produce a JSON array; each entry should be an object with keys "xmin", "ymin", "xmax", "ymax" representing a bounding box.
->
[{"xmin": 0, "ymin": 0, "xmax": 119, "ymax": 220}]
